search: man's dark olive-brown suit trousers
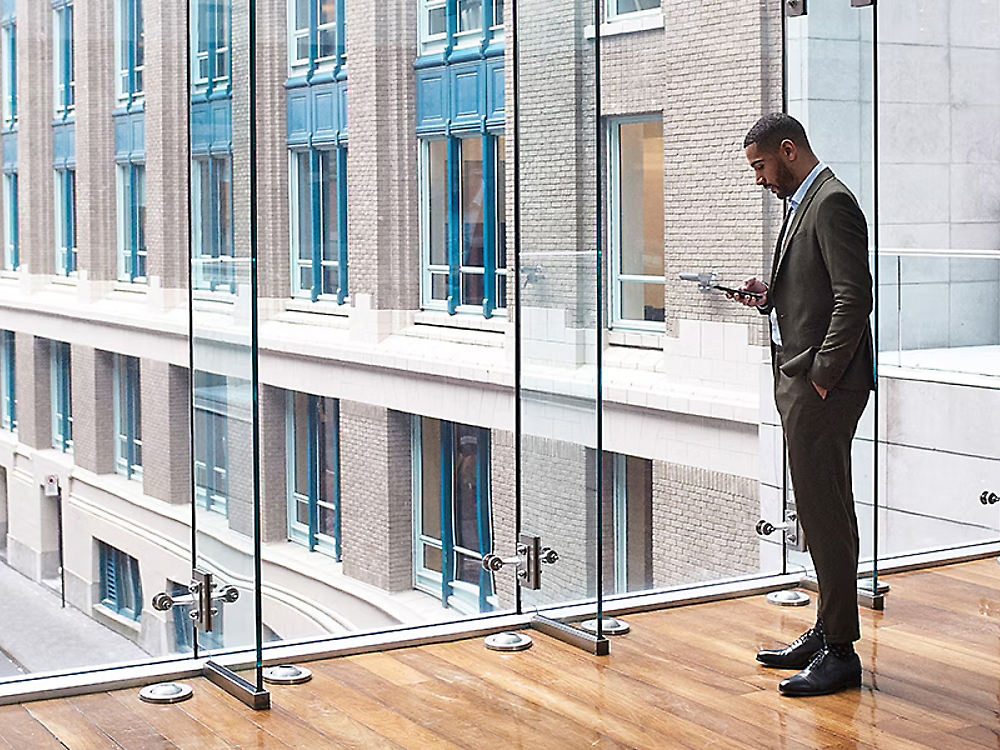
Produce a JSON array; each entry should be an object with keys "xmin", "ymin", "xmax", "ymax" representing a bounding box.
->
[{"xmin": 774, "ymin": 368, "xmax": 869, "ymax": 643}]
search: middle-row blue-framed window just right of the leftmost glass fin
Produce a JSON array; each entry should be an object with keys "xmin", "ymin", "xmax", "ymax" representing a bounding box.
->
[{"xmin": 290, "ymin": 147, "xmax": 347, "ymax": 303}]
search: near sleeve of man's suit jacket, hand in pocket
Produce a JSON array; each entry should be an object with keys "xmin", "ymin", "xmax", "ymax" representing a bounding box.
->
[{"xmin": 809, "ymin": 192, "xmax": 873, "ymax": 390}]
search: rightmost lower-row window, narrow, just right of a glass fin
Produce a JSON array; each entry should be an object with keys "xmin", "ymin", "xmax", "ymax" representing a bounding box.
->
[{"xmin": 613, "ymin": 455, "xmax": 653, "ymax": 594}]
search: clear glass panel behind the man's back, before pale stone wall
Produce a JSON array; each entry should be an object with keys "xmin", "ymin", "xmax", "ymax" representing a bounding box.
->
[{"xmin": 878, "ymin": 0, "xmax": 1000, "ymax": 557}]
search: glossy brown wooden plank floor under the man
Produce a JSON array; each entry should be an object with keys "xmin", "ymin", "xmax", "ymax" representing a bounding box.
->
[{"xmin": 0, "ymin": 560, "xmax": 1000, "ymax": 750}]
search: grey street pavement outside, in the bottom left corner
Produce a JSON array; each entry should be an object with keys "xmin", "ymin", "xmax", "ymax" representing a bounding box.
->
[{"xmin": 0, "ymin": 557, "xmax": 149, "ymax": 678}]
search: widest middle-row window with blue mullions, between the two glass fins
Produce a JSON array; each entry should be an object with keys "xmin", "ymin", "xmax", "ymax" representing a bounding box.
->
[{"xmin": 421, "ymin": 133, "xmax": 507, "ymax": 317}]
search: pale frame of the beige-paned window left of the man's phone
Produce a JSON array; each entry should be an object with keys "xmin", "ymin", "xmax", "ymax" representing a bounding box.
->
[{"xmin": 608, "ymin": 116, "xmax": 666, "ymax": 333}]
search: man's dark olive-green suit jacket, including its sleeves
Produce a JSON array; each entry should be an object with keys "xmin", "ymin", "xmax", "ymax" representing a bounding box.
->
[{"xmin": 760, "ymin": 169, "xmax": 875, "ymax": 391}]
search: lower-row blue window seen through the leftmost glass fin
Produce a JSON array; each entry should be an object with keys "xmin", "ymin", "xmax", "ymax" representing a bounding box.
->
[{"xmin": 194, "ymin": 370, "xmax": 229, "ymax": 515}]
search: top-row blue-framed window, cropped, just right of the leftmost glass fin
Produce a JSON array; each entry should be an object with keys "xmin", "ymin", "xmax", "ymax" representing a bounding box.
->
[{"xmin": 288, "ymin": 0, "xmax": 346, "ymax": 70}]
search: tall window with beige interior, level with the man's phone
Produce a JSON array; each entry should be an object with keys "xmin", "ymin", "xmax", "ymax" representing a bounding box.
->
[{"xmin": 609, "ymin": 119, "xmax": 664, "ymax": 328}]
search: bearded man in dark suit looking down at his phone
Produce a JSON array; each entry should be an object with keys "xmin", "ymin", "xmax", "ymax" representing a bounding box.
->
[{"xmin": 732, "ymin": 113, "xmax": 875, "ymax": 696}]
